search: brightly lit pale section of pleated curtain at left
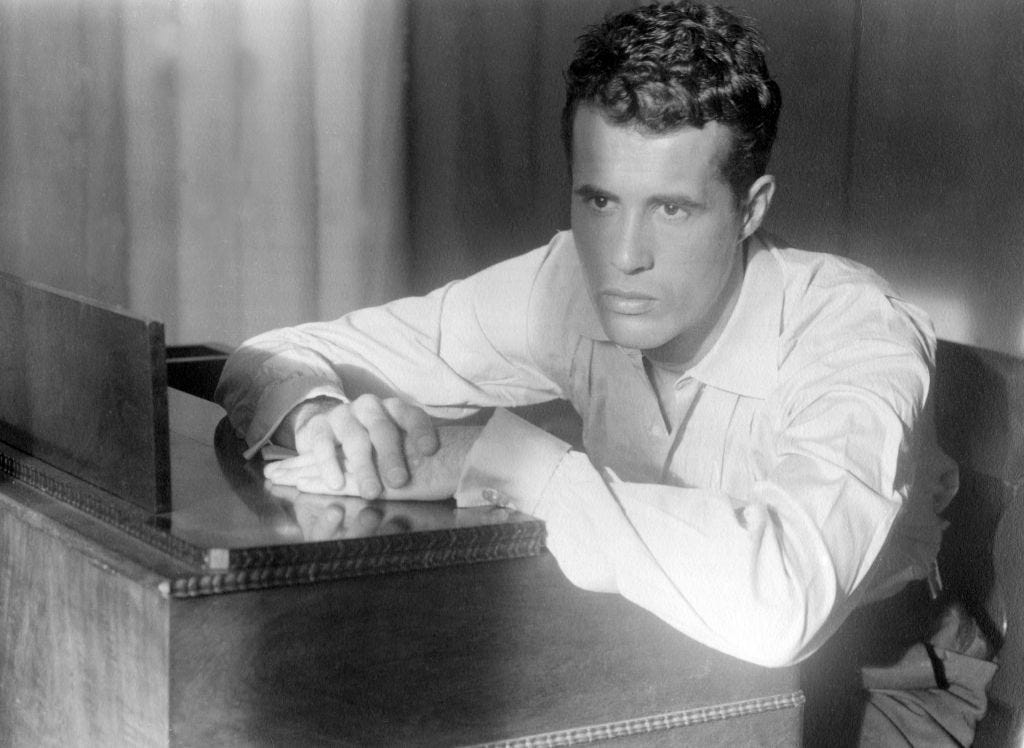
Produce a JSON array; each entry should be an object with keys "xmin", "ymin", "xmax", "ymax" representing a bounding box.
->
[{"xmin": 0, "ymin": 0, "xmax": 409, "ymax": 344}]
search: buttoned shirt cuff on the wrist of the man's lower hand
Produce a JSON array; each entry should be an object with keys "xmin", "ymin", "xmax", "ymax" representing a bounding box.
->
[{"xmin": 455, "ymin": 408, "xmax": 569, "ymax": 514}]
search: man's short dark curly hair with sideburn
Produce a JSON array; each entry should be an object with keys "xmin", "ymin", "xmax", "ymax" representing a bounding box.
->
[{"xmin": 562, "ymin": 2, "xmax": 781, "ymax": 201}]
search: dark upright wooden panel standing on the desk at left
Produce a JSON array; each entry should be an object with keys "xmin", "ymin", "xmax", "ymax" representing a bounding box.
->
[{"xmin": 0, "ymin": 274, "xmax": 171, "ymax": 512}]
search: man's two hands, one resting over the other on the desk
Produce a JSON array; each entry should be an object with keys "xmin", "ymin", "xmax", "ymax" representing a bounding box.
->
[{"xmin": 264, "ymin": 394, "xmax": 480, "ymax": 499}]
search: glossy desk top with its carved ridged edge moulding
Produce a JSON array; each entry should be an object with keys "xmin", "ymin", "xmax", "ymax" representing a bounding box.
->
[{"xmin": 0, "ymin": 381, "xmax": 544, "ymax": 577}]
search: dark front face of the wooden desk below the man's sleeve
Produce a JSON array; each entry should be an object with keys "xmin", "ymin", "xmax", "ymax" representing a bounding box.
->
[{"xmin": 171, "ymin": 554, "xmax": 800, "ymax": 746}]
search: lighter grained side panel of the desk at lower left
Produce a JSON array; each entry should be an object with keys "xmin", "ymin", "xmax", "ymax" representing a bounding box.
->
[{"xmin": 0, "ymin": 483, "xmax": 169, "ymax": 746}]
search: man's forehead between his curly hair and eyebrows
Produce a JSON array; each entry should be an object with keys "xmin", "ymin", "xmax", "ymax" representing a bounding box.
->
[{"xmin": 572, "ymin": 107, "xmax": 733, "ymax": 186}]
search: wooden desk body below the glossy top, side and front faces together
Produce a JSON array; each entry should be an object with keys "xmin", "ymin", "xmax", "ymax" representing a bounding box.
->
[{"xmin": 0, "ymin": 385, "xmax": 803, "ymax": 746}]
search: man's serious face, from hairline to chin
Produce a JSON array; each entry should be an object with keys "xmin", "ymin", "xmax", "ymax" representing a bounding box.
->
[{"xmin": 572, "ymin": 106, "xmax": 745, "ymax": 365}]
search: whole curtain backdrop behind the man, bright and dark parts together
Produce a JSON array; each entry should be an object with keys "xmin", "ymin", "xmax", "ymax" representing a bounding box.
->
[{"xmin": 0, "ymin": 0, "xmax": 1024, "ymax": 354}]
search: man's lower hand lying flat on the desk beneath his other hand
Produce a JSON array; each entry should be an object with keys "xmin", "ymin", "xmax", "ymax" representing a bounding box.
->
[{"xmin": 263, "ymin": 425, "xmax": 481, "ymax": 501}]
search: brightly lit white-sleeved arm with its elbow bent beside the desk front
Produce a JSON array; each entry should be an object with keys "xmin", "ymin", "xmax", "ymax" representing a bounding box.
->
[{"xmin": 457, "ymin": 344, "xmax": 928, "ymax": 666}]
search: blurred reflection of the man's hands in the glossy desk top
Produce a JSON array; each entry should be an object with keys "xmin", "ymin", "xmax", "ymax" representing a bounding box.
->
[{"xmin": 267, "ymin": 483, "xmax": 454, "ymax": 541}]
